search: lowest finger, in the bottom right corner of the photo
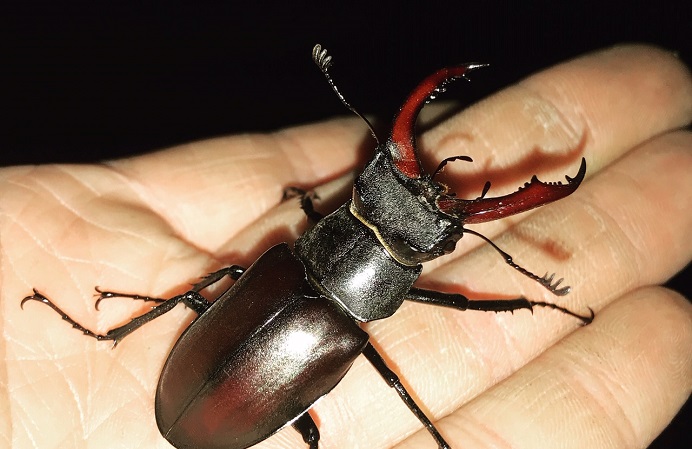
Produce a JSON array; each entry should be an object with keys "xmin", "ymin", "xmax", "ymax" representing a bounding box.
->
[{"xmin": 400, "ymin": 288, "xmax": 692, "ymax": 449}]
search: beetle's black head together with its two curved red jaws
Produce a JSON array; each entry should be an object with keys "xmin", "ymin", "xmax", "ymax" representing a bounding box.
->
[{"xmin": 351, "ymin": 64, "xmax": 586, "ymax": 265}]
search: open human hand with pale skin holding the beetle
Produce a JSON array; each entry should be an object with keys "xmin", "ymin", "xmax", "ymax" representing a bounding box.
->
[{"xmin": 0, "ymin": 47, "xmax": 692, "ymax": 449}]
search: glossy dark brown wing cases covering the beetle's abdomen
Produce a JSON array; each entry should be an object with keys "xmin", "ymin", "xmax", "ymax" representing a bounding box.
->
[{"xmin": 156, "ymin": 244, "xmax": 368, "ymax": 449}]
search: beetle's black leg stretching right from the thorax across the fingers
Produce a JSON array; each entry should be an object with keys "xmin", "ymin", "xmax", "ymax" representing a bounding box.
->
[{"xmin": 406, "ymin": 288, "xmax": 594, "ymax": 324}]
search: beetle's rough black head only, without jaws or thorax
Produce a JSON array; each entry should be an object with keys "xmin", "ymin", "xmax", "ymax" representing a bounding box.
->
[{"xmin": 351, "ymin": 147, "xmax": 462, "ymax": 265}]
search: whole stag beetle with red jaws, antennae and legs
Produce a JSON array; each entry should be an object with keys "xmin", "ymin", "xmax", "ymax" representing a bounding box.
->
[{"xmin": 21, "ymin": 45, "xmax": 594, "ymax": 449}]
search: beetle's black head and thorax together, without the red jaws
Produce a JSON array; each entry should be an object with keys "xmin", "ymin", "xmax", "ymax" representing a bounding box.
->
[{"xmin": 295, "ymin": 148, "xmax": 461, "ymax": 321}]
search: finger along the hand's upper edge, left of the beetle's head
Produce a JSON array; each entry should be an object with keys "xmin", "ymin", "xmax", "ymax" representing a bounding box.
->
[{"xmin": 110, "ymin": 119, "xmax": 371, "ymax": 252}]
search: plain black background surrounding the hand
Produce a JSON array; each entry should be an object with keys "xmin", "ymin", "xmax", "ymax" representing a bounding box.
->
[{"xmin": 0, "ymin": 0, "xmax": 692, "ymax": 449}]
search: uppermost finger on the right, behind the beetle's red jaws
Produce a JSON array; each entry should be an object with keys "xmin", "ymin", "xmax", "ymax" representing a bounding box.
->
[{"xmin": 423, "ymin": 46, "xmax": 692, "ymax": 184}]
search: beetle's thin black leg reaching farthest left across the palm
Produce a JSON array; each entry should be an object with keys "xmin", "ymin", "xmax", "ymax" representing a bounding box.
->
[{"xmin": 21, "ymin": 289, "xmax": 209, "ymax": 347}]
